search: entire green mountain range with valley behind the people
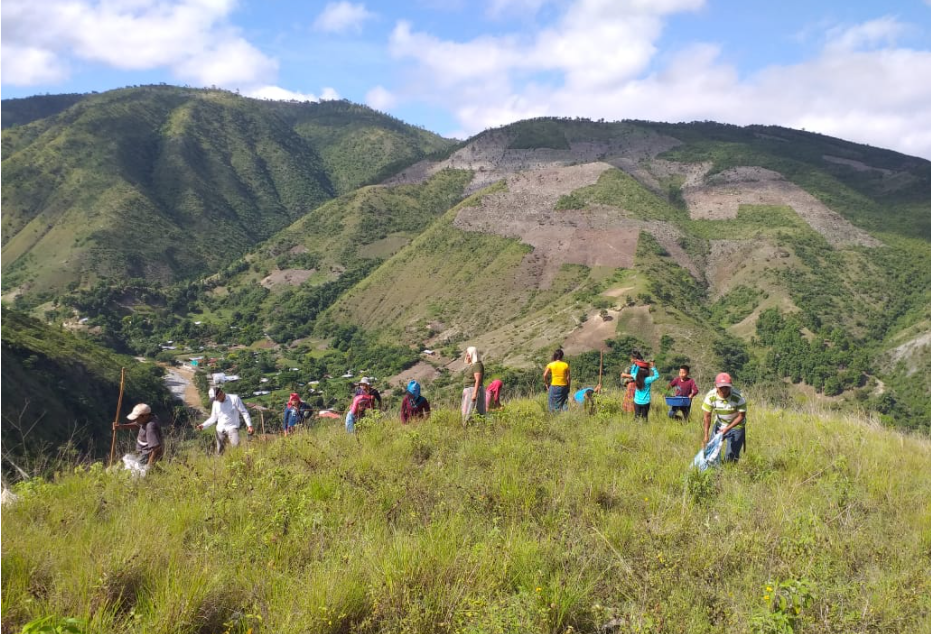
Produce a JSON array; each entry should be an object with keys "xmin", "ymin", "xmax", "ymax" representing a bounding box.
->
[{"xmin": 2, "ymin": 86, "xmax": 931, "ymax": 460}]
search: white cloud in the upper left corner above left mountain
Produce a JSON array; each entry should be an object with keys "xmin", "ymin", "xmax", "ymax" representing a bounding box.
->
[{"xmin": 3, "ymin": 0, "xmax": 277, "ymax": 87}]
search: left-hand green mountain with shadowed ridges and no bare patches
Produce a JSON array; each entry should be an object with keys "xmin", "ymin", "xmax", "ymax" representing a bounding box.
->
[{"xmin": 3, "ymin": 86, "xmax": 447, "ymax": 296}]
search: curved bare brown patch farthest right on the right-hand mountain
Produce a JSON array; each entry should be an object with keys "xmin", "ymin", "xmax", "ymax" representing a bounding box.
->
[{"xmin": 682, "ymin": 167, "xmax": 882, "ymax": 247}]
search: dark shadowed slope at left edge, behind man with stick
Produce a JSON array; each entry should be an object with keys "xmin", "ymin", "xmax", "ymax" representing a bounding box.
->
[{"xmin": 0, "ymin": 308, "xmax": 173, "ymax": 473}]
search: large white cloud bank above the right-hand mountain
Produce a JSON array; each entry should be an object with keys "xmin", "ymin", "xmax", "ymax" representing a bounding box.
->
[{"xmin": 385, "ymin": 5, "xmax": 931, "ymax": 157}]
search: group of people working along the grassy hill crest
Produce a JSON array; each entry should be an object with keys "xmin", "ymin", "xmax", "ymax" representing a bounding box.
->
[{"xmin": 113, "ymin": 346, "xmax": 747, "ymax": 466}]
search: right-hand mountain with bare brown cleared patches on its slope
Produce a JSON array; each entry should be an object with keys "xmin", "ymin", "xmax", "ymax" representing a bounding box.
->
[{"xmin": 328, "ymin": 119, "xmax": 931, "ymax": 428}]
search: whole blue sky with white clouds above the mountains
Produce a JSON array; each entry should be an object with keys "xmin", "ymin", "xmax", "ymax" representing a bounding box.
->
[{"xmin": 0, "ymin": 0, "xmax": 931, "ymax": 158}]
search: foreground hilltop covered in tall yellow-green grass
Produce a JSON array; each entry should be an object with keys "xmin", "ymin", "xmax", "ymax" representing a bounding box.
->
[{"xmin": 2, "ymin": 395, "xmax": 931, "ymax": 634}]
